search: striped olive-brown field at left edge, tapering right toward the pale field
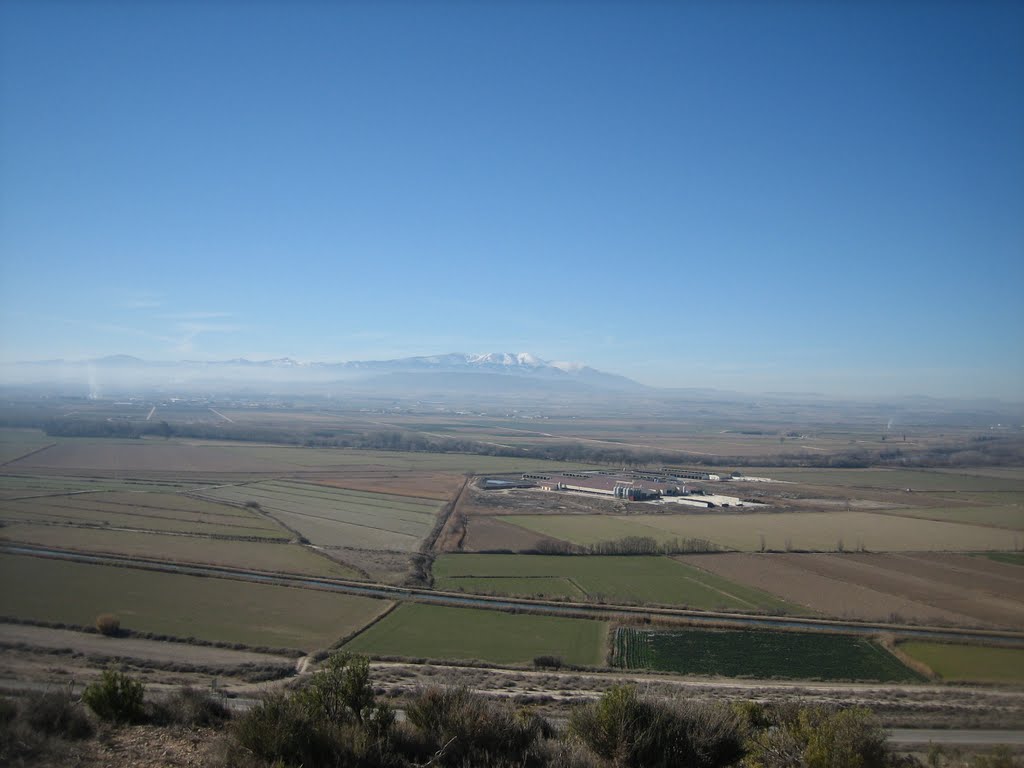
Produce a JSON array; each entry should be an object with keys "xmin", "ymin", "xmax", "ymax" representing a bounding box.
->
[{"xmin": 0, "ymin": 493, "xmax": 292, "ymax": 540}]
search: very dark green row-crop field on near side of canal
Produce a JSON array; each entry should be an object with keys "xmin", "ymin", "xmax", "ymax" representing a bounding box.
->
[{"xmin": 613, "ymin": 627, "xmax": 924, "ymax": 682}]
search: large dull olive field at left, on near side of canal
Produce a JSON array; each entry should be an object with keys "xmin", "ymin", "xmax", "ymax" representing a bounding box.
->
[{"xmin": 0, "ymin": 554, "xmax": 389, "ymax": 650}]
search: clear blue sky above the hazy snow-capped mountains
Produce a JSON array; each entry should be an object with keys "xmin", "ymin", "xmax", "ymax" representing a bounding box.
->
[{"xmin": 0, "ymin": 1, "xmax": 1024, "ymax": 399}]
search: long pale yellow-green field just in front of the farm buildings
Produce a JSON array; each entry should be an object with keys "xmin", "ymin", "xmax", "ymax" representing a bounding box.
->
[{"xmin": 502, "ymin": 511, "xmax": 1013, "ymax": 552}]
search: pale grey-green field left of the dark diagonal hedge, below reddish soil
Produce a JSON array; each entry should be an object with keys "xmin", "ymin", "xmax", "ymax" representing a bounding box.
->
[{"xmin": 198, "ymin": 480, "xmax": 441, "ymax": 552}]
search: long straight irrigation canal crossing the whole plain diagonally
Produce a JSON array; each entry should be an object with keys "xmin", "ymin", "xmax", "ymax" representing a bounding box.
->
[{"xmin": 8, "ymin": 544, "xmax": 1024, "ymax": 647}]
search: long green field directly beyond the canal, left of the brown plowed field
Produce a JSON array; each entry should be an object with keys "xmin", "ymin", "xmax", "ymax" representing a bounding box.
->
[{"xmin": 434, "ymin": 554, "xmax": 800, "ymax": 612}]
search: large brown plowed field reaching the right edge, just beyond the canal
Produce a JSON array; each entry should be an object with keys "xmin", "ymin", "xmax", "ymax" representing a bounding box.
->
[{"xmin": 679, "ymin": 553, "xmax": 1024, "ymax": 629}]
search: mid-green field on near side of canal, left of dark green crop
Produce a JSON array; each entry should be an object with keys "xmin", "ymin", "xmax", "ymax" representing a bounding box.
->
[{"xmin": 345, "ymin": 603, "xmax": 607, "ymax": 665}]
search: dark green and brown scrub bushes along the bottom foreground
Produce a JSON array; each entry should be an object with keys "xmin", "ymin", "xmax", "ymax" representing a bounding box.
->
[{"xmin": 8, "ymin": 652, "xmax": 1021, "ymax": 768}]
